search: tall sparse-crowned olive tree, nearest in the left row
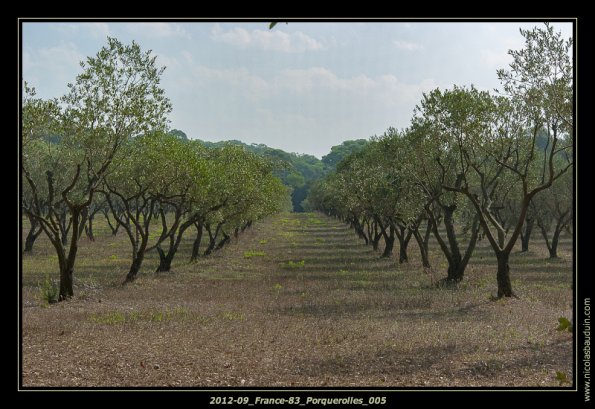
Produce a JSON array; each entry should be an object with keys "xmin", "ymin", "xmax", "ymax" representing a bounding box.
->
[{"xmin": 22, "ymin": 37, "xmax": 171, "ymax": 300}]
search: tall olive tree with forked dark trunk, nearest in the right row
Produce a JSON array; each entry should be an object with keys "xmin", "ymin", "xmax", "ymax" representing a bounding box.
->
[{"xmin": 414, "ymin": 25, "xmax": 573, "ymax": 297}]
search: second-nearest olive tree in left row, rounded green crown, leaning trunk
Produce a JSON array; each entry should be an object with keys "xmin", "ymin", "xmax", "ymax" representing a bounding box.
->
[{"xmin": 102, "ymin": 132, "xmax": 199, "ymax": 283}]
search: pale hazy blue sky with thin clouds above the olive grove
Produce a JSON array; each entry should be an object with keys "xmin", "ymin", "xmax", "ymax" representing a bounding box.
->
[{"xmin": 22, "ymin": 22, "xmax": 572, "ymax": 157}]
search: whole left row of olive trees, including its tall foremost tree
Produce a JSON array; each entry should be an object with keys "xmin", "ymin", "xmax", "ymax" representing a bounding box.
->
[{"xmin": 21, "ymin": 38, "xmax": 287, "ymax": 300}]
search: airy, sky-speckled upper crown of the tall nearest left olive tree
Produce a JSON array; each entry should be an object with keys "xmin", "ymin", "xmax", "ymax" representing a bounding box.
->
[{"xmin": 63, "ymin": 37, "xmax": 171, "ymax": 142}]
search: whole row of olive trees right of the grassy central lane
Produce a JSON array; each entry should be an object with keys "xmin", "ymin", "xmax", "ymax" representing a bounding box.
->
[{"xmin": 309, "ymin": 24, "xmax": 574, "ymax": 297}]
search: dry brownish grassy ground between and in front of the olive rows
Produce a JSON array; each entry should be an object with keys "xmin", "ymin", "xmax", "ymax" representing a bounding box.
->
[{"xmin": 22, "ymin": 214, "xmax": 572, "ymax": 387}]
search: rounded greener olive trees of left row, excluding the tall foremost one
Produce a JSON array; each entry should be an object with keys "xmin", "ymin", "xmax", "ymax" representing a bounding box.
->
[{"xmin": 101, "ymin": 134, "xmax": 288, "ymax": 282}]
